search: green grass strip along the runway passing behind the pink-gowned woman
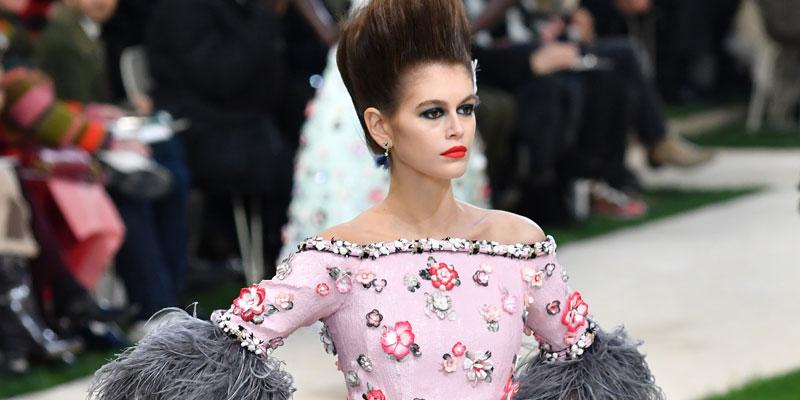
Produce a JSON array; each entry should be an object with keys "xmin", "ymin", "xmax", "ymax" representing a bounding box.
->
[{"xmin": 0, "ymin": 189, "xmax": 755, "ymax": 398}]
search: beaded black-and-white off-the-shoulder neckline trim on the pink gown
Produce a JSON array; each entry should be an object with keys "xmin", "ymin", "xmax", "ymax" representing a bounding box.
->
[{"xmin": 290, "ymin": 235, "xmax": 557, "ymax": 259}]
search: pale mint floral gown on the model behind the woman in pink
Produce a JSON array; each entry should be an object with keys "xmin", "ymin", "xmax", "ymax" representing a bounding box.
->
[{"xmin": 281, "ymin": 47, "xmax": 489, "ymax": 257}]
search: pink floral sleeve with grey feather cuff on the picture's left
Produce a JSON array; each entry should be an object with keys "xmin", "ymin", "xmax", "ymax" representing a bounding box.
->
[{"xmin": 90, "ymin": 252, "xmax": 349, "ymax": 400}]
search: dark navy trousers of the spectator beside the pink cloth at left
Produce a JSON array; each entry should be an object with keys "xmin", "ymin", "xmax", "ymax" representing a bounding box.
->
[{"xmin": 111, "ymin": 138, "xmax": 189, "ymax": 318}]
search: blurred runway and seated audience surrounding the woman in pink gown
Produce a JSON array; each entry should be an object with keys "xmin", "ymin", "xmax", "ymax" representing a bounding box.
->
[{"xmin": 0, "ymin": 0, "xmax": 800, "ymax": 400}]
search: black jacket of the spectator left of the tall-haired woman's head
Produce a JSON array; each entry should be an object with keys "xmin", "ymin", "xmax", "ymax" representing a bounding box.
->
[{"xmin": 147, "ymin": 0, "xmax": 284, "ymax": 123}]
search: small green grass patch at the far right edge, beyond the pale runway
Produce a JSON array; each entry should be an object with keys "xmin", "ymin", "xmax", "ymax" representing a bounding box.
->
[{"xmin": 688, "ymin": 124, "xmax": 800, "ymax": 148}]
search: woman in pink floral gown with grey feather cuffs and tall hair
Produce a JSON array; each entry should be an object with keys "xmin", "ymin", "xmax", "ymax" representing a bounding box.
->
[{"xmin": 92, "ymin": 0, "xmax": 662, "ymax": 400}]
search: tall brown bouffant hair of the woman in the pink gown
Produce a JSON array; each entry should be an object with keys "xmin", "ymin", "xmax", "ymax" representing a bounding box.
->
[{"xmin": 336, "ymin": 0, "xmax": 471, "ymax": 154}]
